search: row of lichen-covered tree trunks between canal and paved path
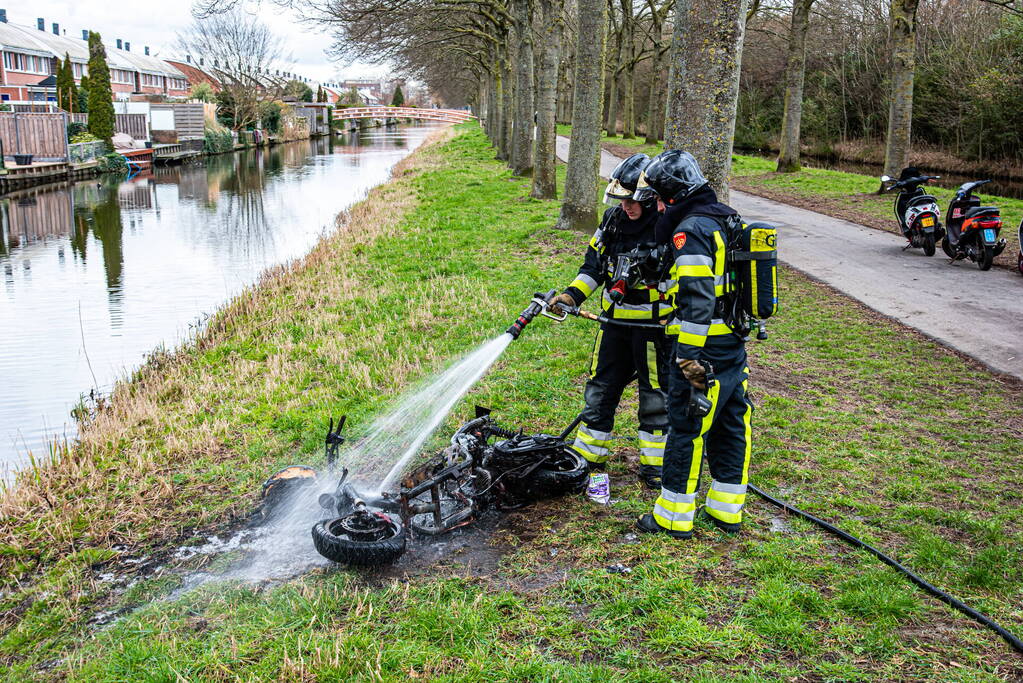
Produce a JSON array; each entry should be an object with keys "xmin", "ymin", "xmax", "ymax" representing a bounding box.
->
[{"xmin": 478, "ymin": 0, "xmax": 749, "ymax": 230}]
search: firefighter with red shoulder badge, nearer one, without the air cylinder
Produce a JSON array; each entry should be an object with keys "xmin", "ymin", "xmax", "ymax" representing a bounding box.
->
[{"xmin": 634, "ymin": 149, "xmax": 753, "ymax": 539}]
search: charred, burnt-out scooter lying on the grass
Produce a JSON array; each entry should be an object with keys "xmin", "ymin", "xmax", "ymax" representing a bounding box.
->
[{"xmin": 264, "ymin": 407, "xmax": 587, "ymax": 566}]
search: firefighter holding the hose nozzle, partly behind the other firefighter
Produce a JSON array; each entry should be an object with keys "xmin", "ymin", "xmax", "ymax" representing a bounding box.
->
[{"xmin": 550, "ymin": 154, "xmax": 672, "ymax": 489}]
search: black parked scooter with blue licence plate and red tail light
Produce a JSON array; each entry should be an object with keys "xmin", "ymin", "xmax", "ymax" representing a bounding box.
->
[{"xmin": 941, "ymin": 180, "xmax": 1006, "ymax": 270}]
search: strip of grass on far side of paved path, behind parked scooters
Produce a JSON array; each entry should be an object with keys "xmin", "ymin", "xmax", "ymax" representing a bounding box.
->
[{"xmin": 558, "ymin": 126, "xmax": 1023, "ymax": 268}]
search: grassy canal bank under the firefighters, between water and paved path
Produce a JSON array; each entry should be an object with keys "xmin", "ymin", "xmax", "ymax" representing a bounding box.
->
[{"xmin": 0, "ymin": 126, "xmax": 1023, "ymax": 681}]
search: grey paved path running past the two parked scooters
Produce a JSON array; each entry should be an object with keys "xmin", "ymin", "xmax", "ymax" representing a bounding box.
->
[{"xmin": 558, "ymin": 136, "xmax": 1023, "ymax": 379}]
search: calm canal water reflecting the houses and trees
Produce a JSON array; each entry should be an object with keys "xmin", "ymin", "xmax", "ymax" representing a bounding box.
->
[{"xmin": 0, "ymin": 126, "xmax": 436, "ymax": 480}]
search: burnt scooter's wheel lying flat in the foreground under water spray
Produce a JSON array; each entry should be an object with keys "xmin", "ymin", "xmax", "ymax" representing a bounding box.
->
[{"xmin": 313, "ymin": 511, "xmax": 406, "ymax": 566}]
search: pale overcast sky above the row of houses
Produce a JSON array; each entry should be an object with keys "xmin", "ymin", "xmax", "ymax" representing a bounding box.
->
[{"xmin": 7, "ymin": 0, "xmax": 388, "ymax": 82}]
